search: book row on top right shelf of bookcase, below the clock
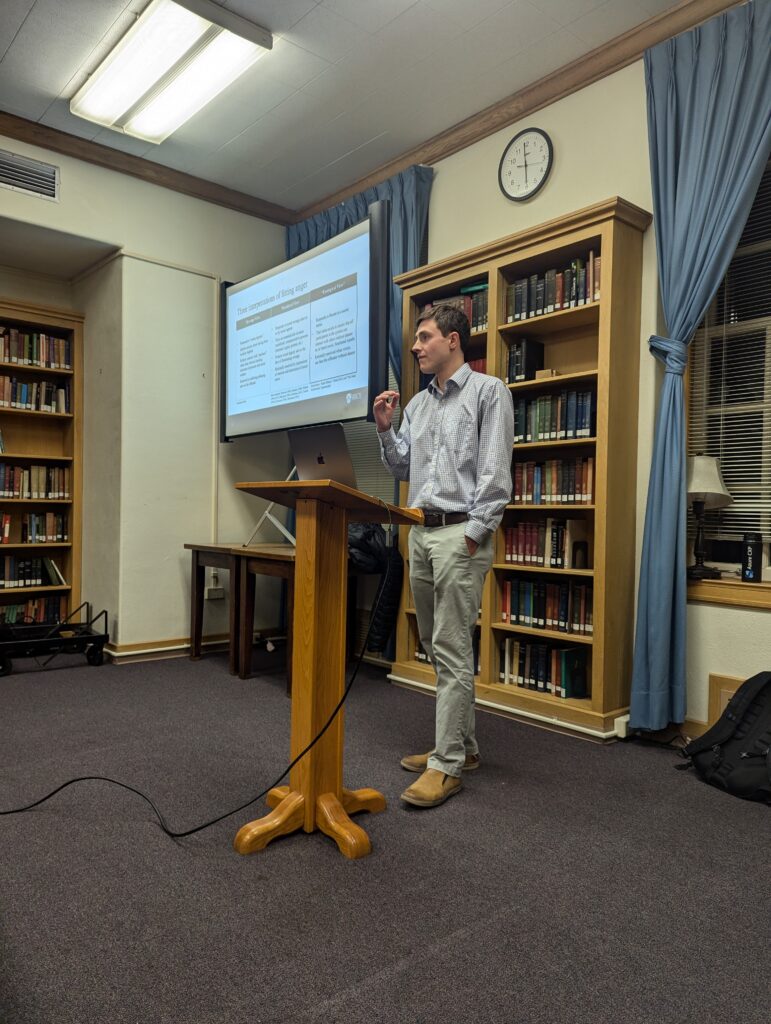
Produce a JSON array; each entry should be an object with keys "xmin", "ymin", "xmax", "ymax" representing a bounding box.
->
[{"xmin": 505, "ymin": 250, "xmax": 602, "ymax": 324}]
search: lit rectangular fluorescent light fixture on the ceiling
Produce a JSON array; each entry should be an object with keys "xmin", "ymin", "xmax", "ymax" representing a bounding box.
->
[{"xmin": 70, "ymin": 0, "xmax": 273, "ymax": 142}]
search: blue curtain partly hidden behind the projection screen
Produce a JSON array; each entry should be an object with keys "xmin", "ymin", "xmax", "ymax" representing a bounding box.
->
[{"xmin": 287, "ymin": 165, "xmax": 434, "ymax": 383}]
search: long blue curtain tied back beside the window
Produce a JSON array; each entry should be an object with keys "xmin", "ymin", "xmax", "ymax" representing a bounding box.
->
[{"xmin": 630, "ymin": 0, "xmax": 771, "ymax": 730}]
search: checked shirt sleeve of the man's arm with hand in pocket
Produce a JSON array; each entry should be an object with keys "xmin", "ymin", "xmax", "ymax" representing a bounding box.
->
[{"xmin": 466, "ymin": 378, "xmax": 514, "ymax": 544}]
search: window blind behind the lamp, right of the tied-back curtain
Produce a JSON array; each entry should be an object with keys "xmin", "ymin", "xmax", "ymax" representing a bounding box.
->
[{"xmin": 687, "ymin": 157, "xmax": 771, "ymax": 542}]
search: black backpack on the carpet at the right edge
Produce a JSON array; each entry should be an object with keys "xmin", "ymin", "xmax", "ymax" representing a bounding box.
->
[{"xmin": 678, "ymin": 672, "xmax": 771, "ymax": 804}]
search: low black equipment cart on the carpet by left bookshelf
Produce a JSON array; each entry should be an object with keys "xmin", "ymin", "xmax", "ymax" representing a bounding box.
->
[{"xmin": 0, "ymin": 601, "xmax": 110, "ymax": 676}]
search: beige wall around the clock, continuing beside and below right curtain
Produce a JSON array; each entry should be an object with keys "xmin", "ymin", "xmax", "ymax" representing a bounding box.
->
[{"xmin": 429, "ymin": 61, "xmax": 768, "ymax": 721}]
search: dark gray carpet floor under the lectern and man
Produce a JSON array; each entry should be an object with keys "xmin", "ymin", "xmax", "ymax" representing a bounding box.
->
[{"xmin": 0, "ymin": 655, "xmax": 771, "ymax": 1024}]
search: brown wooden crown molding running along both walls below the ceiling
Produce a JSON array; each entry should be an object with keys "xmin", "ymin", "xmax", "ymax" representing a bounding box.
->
[{"xmin": 0, "ymin": 0, "xmax": 745, "ymax": 225}]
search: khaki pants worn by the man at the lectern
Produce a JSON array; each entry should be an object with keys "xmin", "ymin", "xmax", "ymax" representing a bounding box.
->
[{"xmin": 410, "ymin": 522, "xmax": 492, "ymax": 776}]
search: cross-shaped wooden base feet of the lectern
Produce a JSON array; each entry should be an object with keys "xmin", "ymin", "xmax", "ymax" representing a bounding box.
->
[{"xmin": 233, "ymin": 785, "xmax": 386, "ymax": 860}]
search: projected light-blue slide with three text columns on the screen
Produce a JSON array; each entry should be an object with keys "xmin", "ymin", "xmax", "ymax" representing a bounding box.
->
[{"xmin": 226, "ymin": 221, "xmax": 370, "ymax": 432}]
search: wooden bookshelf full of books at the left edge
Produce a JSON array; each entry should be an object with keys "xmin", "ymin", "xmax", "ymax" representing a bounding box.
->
[{"xmin": 0, "ymin": 299, "xmax": 83, "ymax": 625}]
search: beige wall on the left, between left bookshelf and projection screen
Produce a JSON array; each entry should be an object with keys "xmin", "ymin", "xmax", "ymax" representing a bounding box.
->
[{"xmin": 0, "ymin": 132, "xmax": 288, "ymax": 646}]
